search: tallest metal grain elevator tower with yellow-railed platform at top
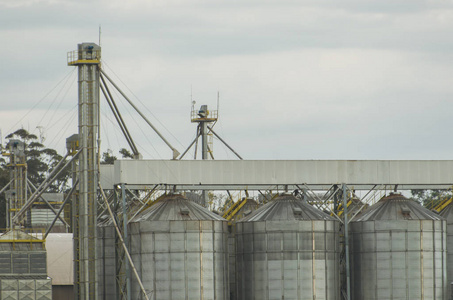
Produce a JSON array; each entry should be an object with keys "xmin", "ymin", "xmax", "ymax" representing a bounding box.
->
[{"xmin": 68, "ymin": 43, "xmax": 101, "ymax": 299}]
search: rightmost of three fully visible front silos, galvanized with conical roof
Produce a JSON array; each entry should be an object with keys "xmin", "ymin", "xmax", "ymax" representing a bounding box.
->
[{"xmin": 350, "ymin": 194, "xmax": 447, "ymax": 300}]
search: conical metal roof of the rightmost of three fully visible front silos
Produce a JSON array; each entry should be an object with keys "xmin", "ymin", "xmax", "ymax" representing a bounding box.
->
[{"xmin": 354, "ymin": 194, "xmax": 443, "ymax": 222}]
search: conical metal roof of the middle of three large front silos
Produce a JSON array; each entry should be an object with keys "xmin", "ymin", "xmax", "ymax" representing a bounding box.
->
[{"xmin": 239, "ymin": 194, "xmax": 335, "ymax": 222}]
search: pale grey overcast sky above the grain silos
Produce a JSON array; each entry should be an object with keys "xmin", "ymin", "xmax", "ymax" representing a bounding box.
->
[{"xmin": 0, "ymin": 0, "xmax": 453, "ymax": 159}]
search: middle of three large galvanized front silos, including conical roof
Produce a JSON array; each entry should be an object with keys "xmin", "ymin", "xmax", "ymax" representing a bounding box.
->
[{"xmin": 236, "ymin": 194, "xmax": 340, "ymax": 300}]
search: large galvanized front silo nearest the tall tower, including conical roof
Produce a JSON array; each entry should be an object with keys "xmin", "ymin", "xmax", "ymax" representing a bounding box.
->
[{"xmin": 129, "ymin": 194, "xmax": 229, "ymax": 300}]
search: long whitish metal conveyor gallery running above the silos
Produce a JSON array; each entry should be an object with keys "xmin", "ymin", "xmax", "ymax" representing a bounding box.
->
[{"xmin": 108, "ymin": 160, "xmax": 453, "ymax": 189}]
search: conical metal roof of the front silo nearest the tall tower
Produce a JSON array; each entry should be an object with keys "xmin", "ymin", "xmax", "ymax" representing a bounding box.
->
[{"xmin": 132, "ymin": 194, "xmax": 226, "ymax": 222}]
